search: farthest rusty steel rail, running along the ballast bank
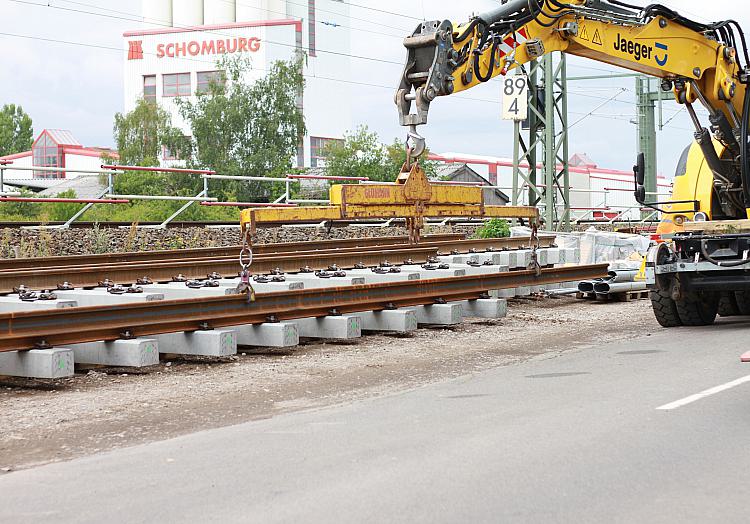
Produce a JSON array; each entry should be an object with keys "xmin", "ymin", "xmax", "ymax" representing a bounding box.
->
[{"xmin": 0, "ymin": 235, "xmax": 554, "ymax": 272}]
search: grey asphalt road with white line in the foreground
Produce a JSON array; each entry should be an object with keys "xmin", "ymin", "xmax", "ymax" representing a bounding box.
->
[{"xmin": 0, "ymin": 321, "xmax": 750, "ymax": 523}]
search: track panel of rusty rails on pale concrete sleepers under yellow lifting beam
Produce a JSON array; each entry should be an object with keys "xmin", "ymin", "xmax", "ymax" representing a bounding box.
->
[{"xmin": 0, "ymin": 235, "xmax": 607, "ymax": 378}]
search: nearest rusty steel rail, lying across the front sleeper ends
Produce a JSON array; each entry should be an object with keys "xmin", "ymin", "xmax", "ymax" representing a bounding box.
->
[{"xmin": 0, "ymin": 264, "xmax": 608, "ymax": 351}]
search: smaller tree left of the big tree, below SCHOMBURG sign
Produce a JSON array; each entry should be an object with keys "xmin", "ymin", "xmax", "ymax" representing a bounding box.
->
[{"xmin": 114, "ymin": 98, "xmax": 188, "ymax": 167}]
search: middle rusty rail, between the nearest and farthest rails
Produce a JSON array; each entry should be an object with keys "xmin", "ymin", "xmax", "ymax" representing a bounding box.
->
[{"xmin": 0, "ymin": 246, "xmax": 444, "ymax": 294}]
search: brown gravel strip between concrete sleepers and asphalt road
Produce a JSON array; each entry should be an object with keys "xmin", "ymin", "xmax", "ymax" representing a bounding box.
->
[{"xmin": 0, "ymin": 297, "xmax": 658, "ymax": 475}]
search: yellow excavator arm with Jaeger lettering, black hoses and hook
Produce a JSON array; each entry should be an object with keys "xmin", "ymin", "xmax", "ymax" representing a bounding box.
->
[{"xmin": 395, "ymin": 0, "xmax": 750, "ymax": 218}]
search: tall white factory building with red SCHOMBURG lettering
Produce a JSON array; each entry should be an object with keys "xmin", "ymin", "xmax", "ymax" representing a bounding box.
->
[{"xmin": 123, "ymin": 0, "xmax": 353, "ymax": 167}]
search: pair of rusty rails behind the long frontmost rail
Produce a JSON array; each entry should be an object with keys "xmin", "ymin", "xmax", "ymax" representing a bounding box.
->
[{"xmin": 0, "ymin": 235, "xmax": 554, "ymax": 294}]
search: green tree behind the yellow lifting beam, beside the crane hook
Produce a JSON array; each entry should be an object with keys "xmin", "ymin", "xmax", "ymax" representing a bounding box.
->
[{"xmin": 323, "ymin": 126, "xmax": 436, "ymax": 182}]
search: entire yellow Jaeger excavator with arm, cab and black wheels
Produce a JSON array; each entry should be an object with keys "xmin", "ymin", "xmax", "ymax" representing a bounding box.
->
[{"xmin": 395, "ymin": 0, "xmax": 750, "ymax": 327}]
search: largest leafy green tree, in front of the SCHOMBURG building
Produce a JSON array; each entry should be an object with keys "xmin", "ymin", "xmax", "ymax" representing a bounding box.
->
[{"xmin": 178, "ymin": 57, "xmax": 306, "ymax": 201}]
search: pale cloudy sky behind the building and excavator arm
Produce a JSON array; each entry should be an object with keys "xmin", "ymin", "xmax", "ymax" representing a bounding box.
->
[{"xmin": 0, "ymin": 0, "xmax": 750, "ymax": 177}]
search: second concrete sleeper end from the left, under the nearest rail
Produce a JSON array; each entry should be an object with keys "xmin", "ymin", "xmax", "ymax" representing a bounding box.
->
[{"xmin": 70, "ymin": 338, "xmax": 159, "ymax": 368}]
